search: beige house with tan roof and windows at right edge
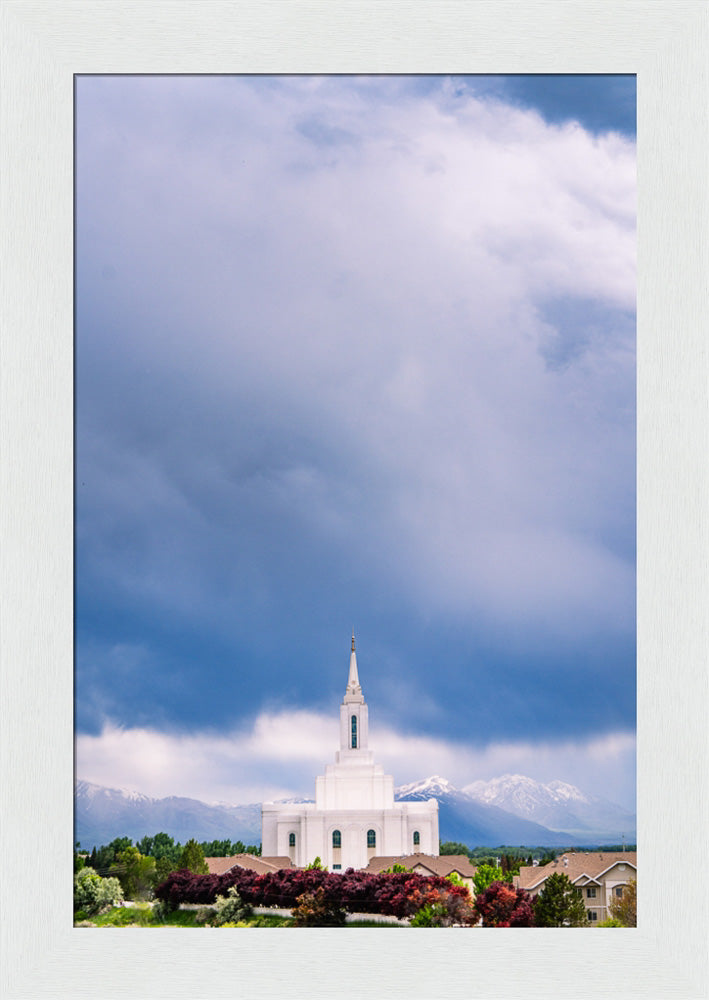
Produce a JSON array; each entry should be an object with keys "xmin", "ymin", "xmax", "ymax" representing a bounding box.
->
[{"xmin": 514, "ymin": 851, "xmax": 637, "ymax": 923}]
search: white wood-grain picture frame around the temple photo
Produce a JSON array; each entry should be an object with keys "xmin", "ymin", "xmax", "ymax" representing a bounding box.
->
[{"xmin": 0, "ymin": 0, "xmax": 709, "ymax": 1000}]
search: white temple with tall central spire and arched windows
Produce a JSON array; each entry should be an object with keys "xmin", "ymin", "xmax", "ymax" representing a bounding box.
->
[{"xmin": 261, "ymin": 635, "xmax": 438, "ymax": 871}]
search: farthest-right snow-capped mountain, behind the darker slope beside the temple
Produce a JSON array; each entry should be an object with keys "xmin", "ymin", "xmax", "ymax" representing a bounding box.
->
[{"xmin": 462, "ymin": 774, "xmax": 636, "ymax": 841}]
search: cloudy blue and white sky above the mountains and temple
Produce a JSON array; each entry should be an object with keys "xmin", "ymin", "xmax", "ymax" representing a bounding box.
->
[{"xmin": 75, "ymin": 76, "xmax": 635, "ymax": 806}]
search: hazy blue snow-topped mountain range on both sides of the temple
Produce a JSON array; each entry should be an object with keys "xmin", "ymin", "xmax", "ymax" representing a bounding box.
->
[{"xmin": 74, "ymin": 774, "xmax": 636, "ymax": 849}]
